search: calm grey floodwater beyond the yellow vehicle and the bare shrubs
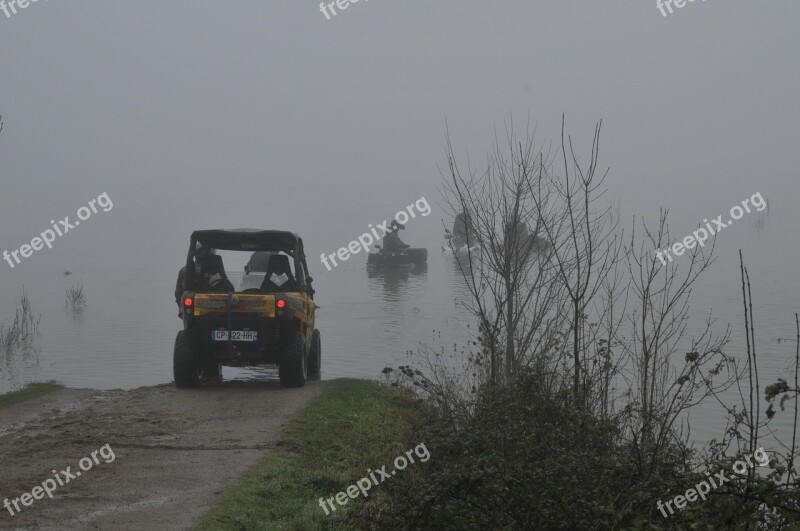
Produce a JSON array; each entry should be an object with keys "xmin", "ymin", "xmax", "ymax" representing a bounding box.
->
[{"xmin": 0, "ymin": 198, "xmax": 800, "ymax": 448}]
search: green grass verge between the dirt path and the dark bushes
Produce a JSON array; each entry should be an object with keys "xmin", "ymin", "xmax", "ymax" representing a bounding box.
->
[{"xmin": 196, "ymin": 379, "xmax": 422, "ymax": 531}]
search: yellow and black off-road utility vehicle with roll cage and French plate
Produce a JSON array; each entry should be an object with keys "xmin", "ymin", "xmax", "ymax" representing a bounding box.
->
[{"xmin": 173, "ymin": 229, "xmax": 321, "ymax": 387}]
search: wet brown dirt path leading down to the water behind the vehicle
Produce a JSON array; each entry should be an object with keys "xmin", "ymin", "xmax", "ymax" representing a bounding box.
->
[{"xmin": 0, "ymin": 382, "xmax": 325, "ymax": 530}]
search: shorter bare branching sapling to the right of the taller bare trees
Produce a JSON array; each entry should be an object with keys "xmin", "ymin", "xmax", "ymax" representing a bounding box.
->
[{"xmin": 622, "ymin": 211, "xmax": 737, "ymax": 475}]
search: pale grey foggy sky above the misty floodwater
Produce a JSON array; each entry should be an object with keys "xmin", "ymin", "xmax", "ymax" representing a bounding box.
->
[{"xmin": 0, "ymin": 0, "xmax": 800, "ymax": 274}]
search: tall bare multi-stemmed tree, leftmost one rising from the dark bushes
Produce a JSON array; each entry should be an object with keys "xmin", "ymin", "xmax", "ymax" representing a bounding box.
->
[{"xmin": 444, "ymin": 120, "xmax": 563, "ymax": 382}]
